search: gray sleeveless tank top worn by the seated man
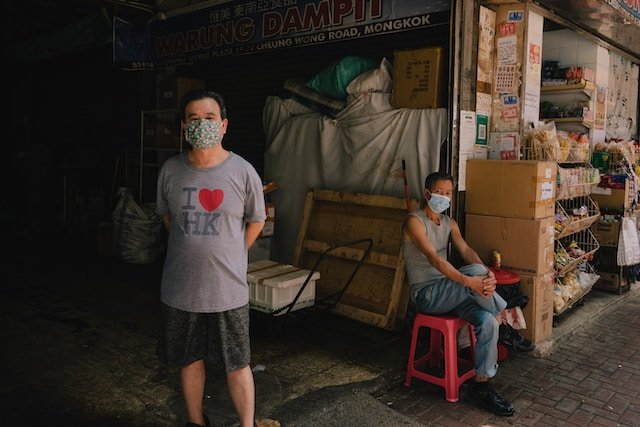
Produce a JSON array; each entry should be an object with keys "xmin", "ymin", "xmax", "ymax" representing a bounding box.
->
[{"xmin": 402, "ymin": 209, "xmax": 451, "ymax": 285}]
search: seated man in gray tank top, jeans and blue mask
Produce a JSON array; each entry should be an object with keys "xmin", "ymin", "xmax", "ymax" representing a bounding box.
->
[{"xmin": 402, "ymin": 172, "xmax": 515, "ymax": 416}]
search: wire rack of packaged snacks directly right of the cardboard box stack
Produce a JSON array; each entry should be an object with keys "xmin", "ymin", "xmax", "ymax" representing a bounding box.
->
[{"xmin": 523, "ymin": 122, "xmax": 600, "ymax": 321}]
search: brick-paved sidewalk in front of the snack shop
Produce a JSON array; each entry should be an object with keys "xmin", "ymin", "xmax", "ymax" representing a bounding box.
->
[{"xmin": 375, "ymin": 285, "xmax": 640, "ymax": 426}]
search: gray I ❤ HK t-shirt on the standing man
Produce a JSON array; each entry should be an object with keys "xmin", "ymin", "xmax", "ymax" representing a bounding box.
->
[{"xmin": 156, "ymin": 152, "xmax": 266, "ymax": 313}]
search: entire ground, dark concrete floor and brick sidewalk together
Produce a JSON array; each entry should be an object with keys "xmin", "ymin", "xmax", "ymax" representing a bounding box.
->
[{"xmin": 0, "ymin": 234, "xmax": 640, "ymax": 427}]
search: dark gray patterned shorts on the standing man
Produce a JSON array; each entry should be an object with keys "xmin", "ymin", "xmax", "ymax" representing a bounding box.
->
[{"xmin": 157, "ymin": 303, "xmax": 251, "ymax": 372}]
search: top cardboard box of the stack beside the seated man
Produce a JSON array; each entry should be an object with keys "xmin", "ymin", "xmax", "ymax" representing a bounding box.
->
[{"xmin": 465, "ymin": 159, "xmax": 558, "ymax": 219}]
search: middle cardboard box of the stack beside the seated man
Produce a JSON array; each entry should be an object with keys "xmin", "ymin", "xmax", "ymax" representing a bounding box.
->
[{"xmin": 465, "ymin": 214, "xmax": 555, "ymax": 274}]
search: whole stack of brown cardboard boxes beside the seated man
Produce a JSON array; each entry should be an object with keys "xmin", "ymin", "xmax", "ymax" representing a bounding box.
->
[{"xmin": 464, "ymin": 159, "xmax": 557, "ymax": 343}]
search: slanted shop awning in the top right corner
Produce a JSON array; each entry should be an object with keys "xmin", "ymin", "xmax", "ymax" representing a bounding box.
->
[{"xmin": 537, "ymin": 0, "xmax": 640, "ymax": 59}]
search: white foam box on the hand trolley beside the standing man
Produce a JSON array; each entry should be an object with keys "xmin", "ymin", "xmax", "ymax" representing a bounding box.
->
[{"xmin": 247, "ymin": 259, "xmax": 320, "ymax": 315}]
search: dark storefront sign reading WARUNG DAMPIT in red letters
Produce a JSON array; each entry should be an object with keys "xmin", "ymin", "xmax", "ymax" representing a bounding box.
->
[{"xmin": 114, "ymin": 0, "xmax": 450, "ymax": 69}]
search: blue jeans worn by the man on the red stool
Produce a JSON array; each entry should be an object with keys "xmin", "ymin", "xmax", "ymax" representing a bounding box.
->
[{"xmin": 415, "ymin": 264, "xmax": 507, "ymax": 378}]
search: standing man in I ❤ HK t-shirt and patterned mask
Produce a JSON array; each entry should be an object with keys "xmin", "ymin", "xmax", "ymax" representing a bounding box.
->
[{"xmin": 156, "ymin": 89, "xmax": 266, "ymax": 427}]
